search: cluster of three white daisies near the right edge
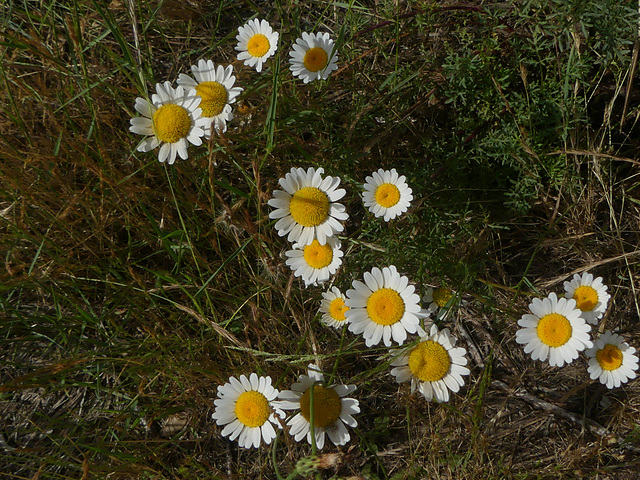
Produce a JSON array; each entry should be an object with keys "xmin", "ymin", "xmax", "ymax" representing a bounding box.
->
[{"xmin": 516, "ymin": 272, "xmax": 638, "ymax": 388}]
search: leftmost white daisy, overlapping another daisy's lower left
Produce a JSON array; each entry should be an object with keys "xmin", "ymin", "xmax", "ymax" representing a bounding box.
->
[{"xmin": 129, "ymin": 82, "xmax": 207, "ymax": 165}]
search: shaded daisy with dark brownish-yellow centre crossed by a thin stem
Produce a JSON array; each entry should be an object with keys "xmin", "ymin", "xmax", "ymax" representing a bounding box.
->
[{"xmin": 279, "ymin": 364, "xmax": 360, "ymax": 449}]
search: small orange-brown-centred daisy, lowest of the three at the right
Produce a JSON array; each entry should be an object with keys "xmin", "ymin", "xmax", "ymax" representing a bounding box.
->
[{"xmin": 586, "ymin": 330, "xmax": 638, "ymax": 388}]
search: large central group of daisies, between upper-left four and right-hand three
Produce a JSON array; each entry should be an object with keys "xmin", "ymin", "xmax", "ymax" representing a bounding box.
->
[{"xmin": 213, "ymin": 167, "xmax": 470, "ymax": 448}]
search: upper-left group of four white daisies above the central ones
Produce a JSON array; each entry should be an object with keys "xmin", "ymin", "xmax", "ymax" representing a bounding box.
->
[{"xmin": 129, "ymin": 19, "xmax": 338, "ymax": 164}]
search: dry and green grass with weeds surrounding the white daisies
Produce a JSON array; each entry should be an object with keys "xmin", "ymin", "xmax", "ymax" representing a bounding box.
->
[{"xmin": 0, "ymin": 0, "xmax": 640, "ymax": 479}]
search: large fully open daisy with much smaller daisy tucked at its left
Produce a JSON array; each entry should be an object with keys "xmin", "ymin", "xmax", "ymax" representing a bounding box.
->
[{"xmin": 345, "ymin": 265, "xmax": 423, "ymax": 347}]
